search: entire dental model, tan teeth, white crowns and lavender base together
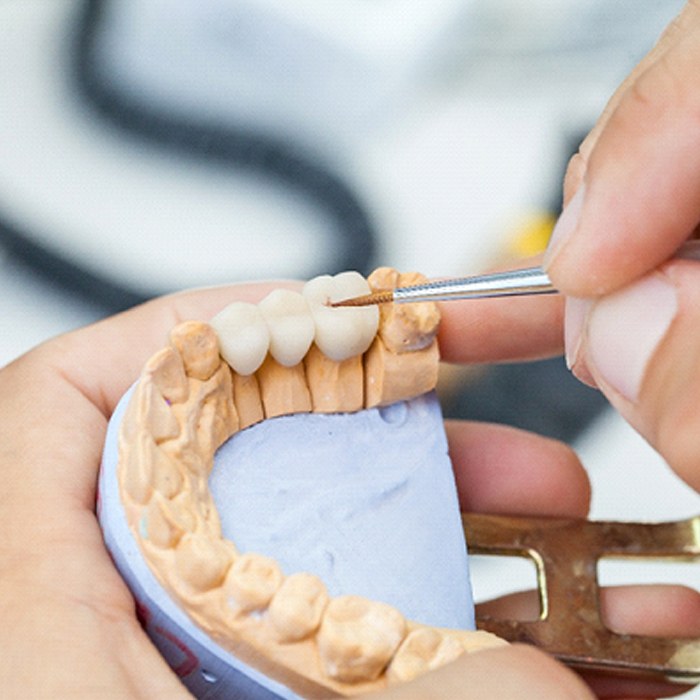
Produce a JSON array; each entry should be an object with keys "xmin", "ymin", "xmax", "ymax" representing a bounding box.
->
[{"xmin": 99, "ymin": 268, "xmax": 504, "ymax": 698}]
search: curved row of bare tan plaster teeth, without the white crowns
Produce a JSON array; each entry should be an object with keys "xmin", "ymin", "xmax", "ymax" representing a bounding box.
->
[{"xmin": 120, "ymin": 336, "xmax": 503, "ymax": 687}]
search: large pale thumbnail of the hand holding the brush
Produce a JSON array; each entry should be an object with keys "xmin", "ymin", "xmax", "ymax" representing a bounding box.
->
[{"xmin": 584, "ymin": 274, "xmax": 678, "ymax": 402}]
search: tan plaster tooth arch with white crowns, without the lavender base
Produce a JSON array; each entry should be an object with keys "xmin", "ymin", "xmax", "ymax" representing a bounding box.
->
[{"xmin": 102, "ymin": 268, "xmax": 505, "ymax": 698}]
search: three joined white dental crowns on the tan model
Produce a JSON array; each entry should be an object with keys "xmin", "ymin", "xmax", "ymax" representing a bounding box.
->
[{"xmin": 211, "ymin": 272, "xmax": 379, "ymax": 376}]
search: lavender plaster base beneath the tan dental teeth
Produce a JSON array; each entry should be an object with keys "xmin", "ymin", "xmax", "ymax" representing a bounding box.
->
[{"xmin": 99, "ymin": 394, "xmax": 474, "ymax": 700}]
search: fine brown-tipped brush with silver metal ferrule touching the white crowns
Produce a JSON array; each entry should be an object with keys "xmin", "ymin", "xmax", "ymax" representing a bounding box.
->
[{"xmin": 330, "ymin": 267, "xmax": 557, "ymax": 307}]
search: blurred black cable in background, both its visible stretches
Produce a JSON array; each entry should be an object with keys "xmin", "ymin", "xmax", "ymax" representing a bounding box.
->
[{"xmin": 0, "ymin": 0, "xmax": 376, "ymax": 313}]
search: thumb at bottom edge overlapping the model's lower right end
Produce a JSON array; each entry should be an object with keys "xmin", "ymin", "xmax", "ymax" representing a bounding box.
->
[{"xmin": 372, "ymin": 645, "xmax": 593, "ymax": 700}]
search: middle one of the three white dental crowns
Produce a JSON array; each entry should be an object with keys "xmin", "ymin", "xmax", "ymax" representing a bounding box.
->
[{"xmin": 258, "ymin": 289, "xmax": 315, "ymax": 367}]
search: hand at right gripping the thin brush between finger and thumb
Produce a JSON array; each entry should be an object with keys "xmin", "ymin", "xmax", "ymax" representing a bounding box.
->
[{"xmin": 545, "ymin": 1, "xmax": 700, "ymax": 489}]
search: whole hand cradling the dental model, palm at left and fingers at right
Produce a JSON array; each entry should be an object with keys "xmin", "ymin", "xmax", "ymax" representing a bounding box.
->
[{"xmin": 0, "ymin": 264, "xmax": 698, "ymax": 700}]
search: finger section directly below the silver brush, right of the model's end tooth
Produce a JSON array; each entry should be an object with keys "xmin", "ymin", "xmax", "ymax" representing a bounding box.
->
[{"xmin": 438, "ymin": 276, "xmax": 564, "ymax": 363}]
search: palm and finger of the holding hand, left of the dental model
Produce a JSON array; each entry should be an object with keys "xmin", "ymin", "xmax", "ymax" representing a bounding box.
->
[{"xmin": 0, "ymin": 285, "xmax": 288, "ymax": 700}]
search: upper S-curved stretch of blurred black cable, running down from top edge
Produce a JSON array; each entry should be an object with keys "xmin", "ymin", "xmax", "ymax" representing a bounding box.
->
[{"xmin": 74, "ymin": 0, "xmax": 376, "ymax": 274}]
